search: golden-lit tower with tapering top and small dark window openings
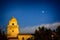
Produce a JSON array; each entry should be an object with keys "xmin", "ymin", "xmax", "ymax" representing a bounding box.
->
[{"xmin": 7, "ymin": 17, "xmax": 19, "ymax": 38}]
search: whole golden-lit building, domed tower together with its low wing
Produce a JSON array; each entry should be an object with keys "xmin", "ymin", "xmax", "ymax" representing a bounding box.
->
[{"xmin": 7, "ymin": 17, "xmax": 34, "ymax": 40}]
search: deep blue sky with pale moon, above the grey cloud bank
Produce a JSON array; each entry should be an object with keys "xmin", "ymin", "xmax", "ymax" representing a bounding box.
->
[{"xmin": 0, "ymin": 0, "xmax": 60, "ymax": 27}]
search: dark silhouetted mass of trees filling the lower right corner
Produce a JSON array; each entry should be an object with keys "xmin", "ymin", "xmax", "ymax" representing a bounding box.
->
[{"xmin": 34, "ymin": 26, "xmax": 60, "ymax": 40}]
